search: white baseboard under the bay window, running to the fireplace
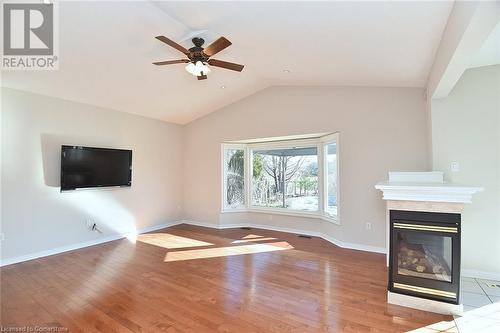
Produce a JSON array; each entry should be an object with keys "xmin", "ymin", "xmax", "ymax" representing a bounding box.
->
[{"xmin": 181, "ymin": 220, "xmax": 387, "ymax": 254}]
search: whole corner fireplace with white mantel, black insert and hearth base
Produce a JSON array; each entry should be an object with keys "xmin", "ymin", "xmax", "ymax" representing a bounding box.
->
[{"xmin": 375, "ymin": 171, "xmax": 483, "ymax": 315}]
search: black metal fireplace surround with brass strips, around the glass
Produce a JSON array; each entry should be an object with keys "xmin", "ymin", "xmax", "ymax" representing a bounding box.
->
[{"xmin": 388, "ymin": 210, "xmax": 461, "ymax": 304}]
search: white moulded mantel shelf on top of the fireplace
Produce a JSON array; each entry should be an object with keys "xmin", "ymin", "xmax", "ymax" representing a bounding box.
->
[{"xmin": 375, "ymin": 181, "xmax": 483, "ymax": 203}]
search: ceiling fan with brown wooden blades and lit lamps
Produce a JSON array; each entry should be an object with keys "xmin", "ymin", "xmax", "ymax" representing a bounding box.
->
[{"xmin": 153, "ymin": 36, "xmax": 244, "ymax": 80}]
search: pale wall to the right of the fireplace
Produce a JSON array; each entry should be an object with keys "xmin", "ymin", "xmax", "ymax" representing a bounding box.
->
[{"xmin": 432, "ymin": 65, "xmax": 500, "ymax": 279}]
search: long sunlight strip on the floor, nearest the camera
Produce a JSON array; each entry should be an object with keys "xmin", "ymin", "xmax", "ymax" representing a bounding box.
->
[{"xmin": 164, "ymin": 242, "xmax": 293, "ymax": 262}]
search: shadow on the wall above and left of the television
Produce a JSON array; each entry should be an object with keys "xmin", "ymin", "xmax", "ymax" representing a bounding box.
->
[{"xmin": 40, "ymin": 133, "xmax": 120, "ymax": 187}]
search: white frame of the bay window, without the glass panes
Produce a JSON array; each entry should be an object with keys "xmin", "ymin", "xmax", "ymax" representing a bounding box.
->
[{"xmin": 221, "ymin": 133, "xmax": 340, "ymax": 224}]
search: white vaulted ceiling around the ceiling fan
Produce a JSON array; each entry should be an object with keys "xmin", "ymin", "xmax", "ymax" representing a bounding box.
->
[{"xmin": 2, "ymin": 1, "xmax": 453, "ymax": 124}]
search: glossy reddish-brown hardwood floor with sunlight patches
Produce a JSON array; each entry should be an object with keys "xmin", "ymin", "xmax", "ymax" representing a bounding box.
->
[{"xmin": 0, "ymin": 225, "xmax": 452, "ymax": 333}]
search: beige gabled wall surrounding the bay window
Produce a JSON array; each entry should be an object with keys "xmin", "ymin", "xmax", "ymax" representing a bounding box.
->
[{"xmin": 184, "ymin": 87, "xmax": 430, "ymax": 247}]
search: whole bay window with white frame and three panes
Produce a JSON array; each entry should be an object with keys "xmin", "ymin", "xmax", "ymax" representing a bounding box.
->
[{"xmin": 222, "ymin": 134, "xmax": 339, "ymax": 223}]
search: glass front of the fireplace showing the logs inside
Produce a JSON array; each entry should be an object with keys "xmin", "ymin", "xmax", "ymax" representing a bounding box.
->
[{"xmin": 396, "ymin": 229, "xmax": 453, "ymax": 282}]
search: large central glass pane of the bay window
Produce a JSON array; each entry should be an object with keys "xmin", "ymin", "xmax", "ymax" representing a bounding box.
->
[{"xmin": 252, "ymin": 147, "xmax": 318, "ymax": 211}]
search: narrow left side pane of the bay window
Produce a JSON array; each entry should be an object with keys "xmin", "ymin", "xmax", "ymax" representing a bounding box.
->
[{"xmin": 224, "ymin": 149, "xmax": 245, "ymax": 208}]
